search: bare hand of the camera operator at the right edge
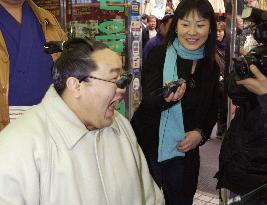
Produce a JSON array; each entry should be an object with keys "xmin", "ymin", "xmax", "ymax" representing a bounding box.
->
[{"xmin": 236, "ymin": 65, "xmax": 267, "ymax": 95}]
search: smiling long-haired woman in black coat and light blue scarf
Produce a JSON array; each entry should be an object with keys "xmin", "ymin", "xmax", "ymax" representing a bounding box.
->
[{"xmin": 131, "ymin": 0, "xmax": 219, "ymax": 205}]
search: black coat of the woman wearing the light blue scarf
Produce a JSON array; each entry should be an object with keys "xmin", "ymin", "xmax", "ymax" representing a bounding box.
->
[{"xmin": 131, "ymin": 45, "xmax": 219, "ymax": 197}]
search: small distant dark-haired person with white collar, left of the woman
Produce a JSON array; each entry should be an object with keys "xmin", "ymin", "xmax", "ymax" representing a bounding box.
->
[{"xmin": 142, "ymin": 15, "xmax": 157, "ymax": 48}]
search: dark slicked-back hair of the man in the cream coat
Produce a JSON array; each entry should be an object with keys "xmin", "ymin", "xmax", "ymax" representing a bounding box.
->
[{"xmin": 52, "ymin": 38, "xmax": 108, "ymax": 95}]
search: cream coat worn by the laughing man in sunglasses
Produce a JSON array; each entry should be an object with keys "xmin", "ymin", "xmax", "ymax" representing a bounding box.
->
[{"xmin": 0, "ymin": 87, "xmax": 164, "ymax": 205}]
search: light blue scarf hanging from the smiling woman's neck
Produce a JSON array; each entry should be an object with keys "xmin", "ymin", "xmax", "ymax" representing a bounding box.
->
[{"xmin": 158, "ymin": 38, "xmax": 205, "ymax": 162}]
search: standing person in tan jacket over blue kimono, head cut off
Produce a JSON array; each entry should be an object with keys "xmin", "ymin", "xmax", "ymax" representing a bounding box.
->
[{"xmin": 0, "ymin": 0, "xmax": 67, "ymax": 130}]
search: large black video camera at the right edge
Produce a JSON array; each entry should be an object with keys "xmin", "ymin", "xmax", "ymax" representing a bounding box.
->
[{"xmin": 233, "ymin": 7, "xmax": 267, "ymax": 80}]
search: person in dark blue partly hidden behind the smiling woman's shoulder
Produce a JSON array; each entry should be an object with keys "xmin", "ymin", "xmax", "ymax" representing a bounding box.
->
[{"xmin": 142, "ymin": 14, "xmax": 173, "ymax": 61}]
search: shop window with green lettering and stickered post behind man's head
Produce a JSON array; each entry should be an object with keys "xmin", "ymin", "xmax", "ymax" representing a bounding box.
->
[{"xmin": 66, "ymin": 0, "xmax": 142, "ymax": 118}]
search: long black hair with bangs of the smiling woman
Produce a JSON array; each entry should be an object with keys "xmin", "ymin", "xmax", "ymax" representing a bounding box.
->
[{"xmin": 165, "ymin": 0, "xmax": 217, "ymax": 63}]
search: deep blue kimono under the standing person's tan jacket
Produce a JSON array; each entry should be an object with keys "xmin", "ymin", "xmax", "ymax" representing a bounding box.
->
[{"xmin": 0, "ymin": 1, "xmax": 53, "ymax": 106}]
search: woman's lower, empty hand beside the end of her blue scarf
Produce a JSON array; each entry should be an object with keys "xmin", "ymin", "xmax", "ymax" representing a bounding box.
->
[{"xmin": 176, "ymin": 130, "xmax": 202, "ymax": 152}]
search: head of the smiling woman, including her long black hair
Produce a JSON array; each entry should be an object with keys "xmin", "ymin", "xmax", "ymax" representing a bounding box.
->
[{"xmin": 166, "ymin": 0, "xmax": 217, "ymax": 61}]
